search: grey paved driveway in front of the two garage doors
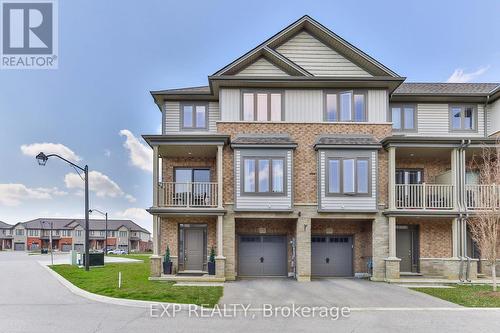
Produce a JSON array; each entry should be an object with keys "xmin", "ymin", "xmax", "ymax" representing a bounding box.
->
[{"xmin": 221, "ymin": 279, "xmax": 459, "ymax": 308}]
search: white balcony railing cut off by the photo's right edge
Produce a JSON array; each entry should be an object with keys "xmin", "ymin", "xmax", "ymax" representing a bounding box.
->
[{"xmin": 465, "ymin": 184, "xmax": 500, "ymax": 210}]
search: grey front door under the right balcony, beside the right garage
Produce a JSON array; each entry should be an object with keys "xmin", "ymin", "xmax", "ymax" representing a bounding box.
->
[{"xmin": 396, "ymin": 225, "xmax": 418, "ymax": 273}]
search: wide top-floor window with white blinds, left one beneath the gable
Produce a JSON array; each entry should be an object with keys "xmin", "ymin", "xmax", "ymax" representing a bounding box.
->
[{"xmin": 242, "ymin": 91, "xmax": 283, "ymax": 121}]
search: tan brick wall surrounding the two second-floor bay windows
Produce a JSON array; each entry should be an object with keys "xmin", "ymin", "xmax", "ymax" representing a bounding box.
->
[{"xmin": 217, "ymin": 122, "xmax": 392, "ymax": 204}]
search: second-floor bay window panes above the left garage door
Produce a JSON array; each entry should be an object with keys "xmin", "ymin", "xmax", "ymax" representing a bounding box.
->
[{"xmin": 243, "ymin": 157, "xmax": 285, "ymax": 194}]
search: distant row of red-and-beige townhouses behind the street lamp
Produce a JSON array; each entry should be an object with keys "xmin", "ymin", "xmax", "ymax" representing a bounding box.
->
[{"xmin": 0, "ymin": 218, "xmax": 151, "ymax": 252}]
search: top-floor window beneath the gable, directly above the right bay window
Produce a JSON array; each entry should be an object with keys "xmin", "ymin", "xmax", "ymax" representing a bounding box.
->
[{"xmin": 324, "ymin": 90, "xmax": 367, "ymax": 122}]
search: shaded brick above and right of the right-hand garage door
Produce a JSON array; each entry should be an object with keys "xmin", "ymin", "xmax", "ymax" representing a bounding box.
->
[{"xmin": 311, "ymin": 219, "xmax": 372, "ymax": 273}]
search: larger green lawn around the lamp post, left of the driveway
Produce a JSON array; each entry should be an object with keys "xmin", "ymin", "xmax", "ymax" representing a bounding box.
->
[{"xmin": 51, "ymin": 255, "xmax": 222, "ymax": 307}]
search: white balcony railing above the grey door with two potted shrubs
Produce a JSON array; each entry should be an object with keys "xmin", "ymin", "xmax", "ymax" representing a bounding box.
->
[{"xmin": 158, "ymin": 182, "xmax": 218, "ymax": 208}]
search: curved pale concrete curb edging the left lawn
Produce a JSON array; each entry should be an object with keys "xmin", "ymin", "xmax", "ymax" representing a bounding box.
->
[{"xmin": 38, "ymin": 262, "xmax": 202, "ymax": 310}]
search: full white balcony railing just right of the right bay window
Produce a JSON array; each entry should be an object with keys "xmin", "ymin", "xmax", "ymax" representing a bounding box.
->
[{"xmin": 395, "ymin": 183, "xmax": 454, "ymax": 210}]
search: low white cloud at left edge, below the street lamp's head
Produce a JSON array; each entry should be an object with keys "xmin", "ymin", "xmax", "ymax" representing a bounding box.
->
[{"xmin": 0, "ymin": 184, "xmax": 67, "ymax": 206}]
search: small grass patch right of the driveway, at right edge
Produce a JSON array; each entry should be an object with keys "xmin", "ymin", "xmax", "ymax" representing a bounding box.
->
[{"xmin": 411, "ymin": 285, "xmax": 500, "ymax": 308}]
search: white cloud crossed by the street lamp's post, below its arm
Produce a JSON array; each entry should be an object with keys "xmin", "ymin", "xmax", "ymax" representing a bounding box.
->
[{"xmin": 64, "ymin": 171, "xmax": 135, "ymax": 202}]
